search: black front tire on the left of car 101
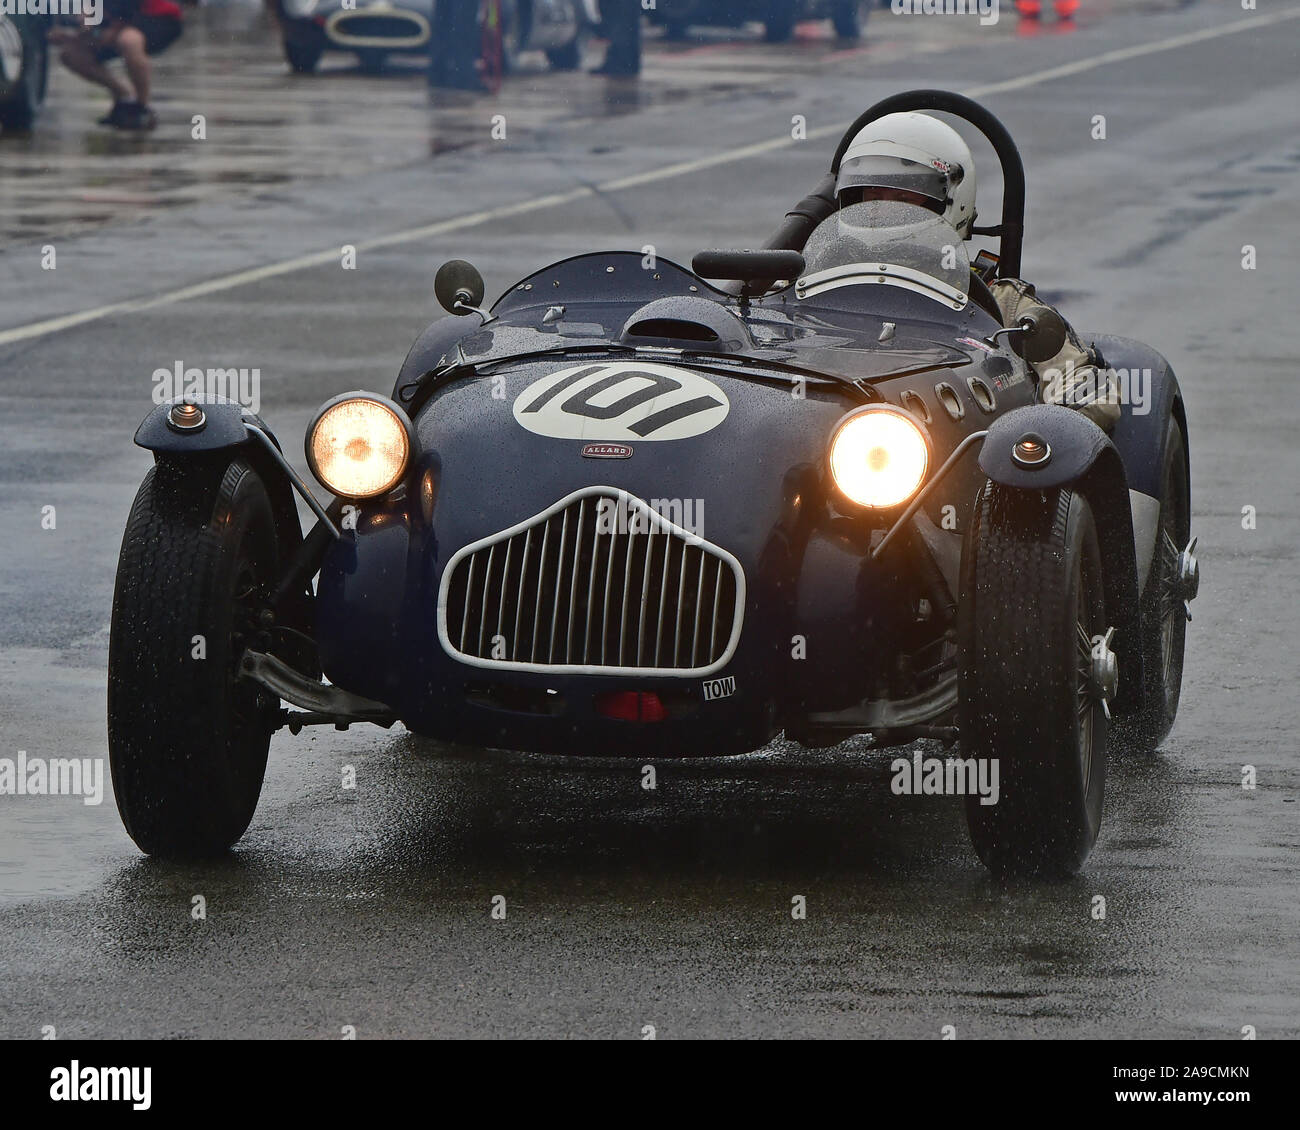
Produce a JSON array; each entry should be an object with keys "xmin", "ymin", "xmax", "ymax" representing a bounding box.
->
[{"xmin": 108, "ymin": 460, "xmax": 280, "ymax": 857}]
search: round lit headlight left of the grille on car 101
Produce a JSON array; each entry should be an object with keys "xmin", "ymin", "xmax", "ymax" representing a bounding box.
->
[{"xmin": 307, "ymin": 393, "xmax": 415, "ymax": 498}]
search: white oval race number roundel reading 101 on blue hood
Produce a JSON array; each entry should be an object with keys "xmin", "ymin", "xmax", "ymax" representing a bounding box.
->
[{"xmin": 515, "ymin": 361, "xmax": 731, "ymax": 443}]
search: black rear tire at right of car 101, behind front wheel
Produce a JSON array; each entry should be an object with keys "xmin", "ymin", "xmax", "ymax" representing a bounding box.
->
[{"xmin": 1115, "ymin": 416, "xmax": 1192, "ymax": 753}]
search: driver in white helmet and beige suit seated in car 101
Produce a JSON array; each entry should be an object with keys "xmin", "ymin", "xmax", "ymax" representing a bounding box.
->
[{"xmin": 809, "ymin": 113, "xmax": 1119, "ymax": 432}]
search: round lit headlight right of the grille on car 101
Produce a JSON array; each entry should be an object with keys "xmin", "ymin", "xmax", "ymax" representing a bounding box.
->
[{"xmin": 831, "ymin": 404, "xmax": 930, "ymax": 510}]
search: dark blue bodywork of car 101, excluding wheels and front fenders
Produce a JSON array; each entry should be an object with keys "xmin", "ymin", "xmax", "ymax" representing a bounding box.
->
[{"xmin": 295, "ymin": 244, "xmax": 1178, "ymax": 753}]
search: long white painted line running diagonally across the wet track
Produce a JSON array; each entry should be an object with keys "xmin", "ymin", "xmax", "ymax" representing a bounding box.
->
[{"xmin": 0, "ymin": 9, "xmax": 1300, "ymax": 346}]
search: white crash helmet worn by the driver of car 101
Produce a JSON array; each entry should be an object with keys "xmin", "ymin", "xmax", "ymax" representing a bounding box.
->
[{"xmin": 835, "ymin": 113, "xmax": 975, "ymax": 239}]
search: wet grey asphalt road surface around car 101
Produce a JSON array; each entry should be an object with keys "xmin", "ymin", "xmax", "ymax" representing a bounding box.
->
[{"xmin": 0, "ymin": 4, "xmax": 1300, "ymax": 1039}]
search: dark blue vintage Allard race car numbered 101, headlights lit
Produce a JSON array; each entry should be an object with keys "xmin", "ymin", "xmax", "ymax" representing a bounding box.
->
[{"xmin": 108, "ymin": 91, "xmax": 1197, "ymax": 874}]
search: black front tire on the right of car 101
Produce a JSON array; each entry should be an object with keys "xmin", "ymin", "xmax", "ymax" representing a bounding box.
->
[{"xmin": 959, "ymin": 482, "xmax": 1106, "ymax": 878}]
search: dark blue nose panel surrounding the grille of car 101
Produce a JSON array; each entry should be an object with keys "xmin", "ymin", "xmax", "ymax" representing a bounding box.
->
[{"xmin": 317, "ymin": 364, "xmax": 844, "ymax": 752}]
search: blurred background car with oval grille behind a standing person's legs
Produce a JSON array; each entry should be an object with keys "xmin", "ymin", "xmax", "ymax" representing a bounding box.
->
[{"xmin": 276, "ymin": 0, "xmax": 586, "ymax": 74}]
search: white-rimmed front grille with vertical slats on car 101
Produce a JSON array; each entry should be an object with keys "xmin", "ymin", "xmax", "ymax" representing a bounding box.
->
[{"xmin": 438, "ymin": 486, "xmax": 745, "ymax": 675}]
